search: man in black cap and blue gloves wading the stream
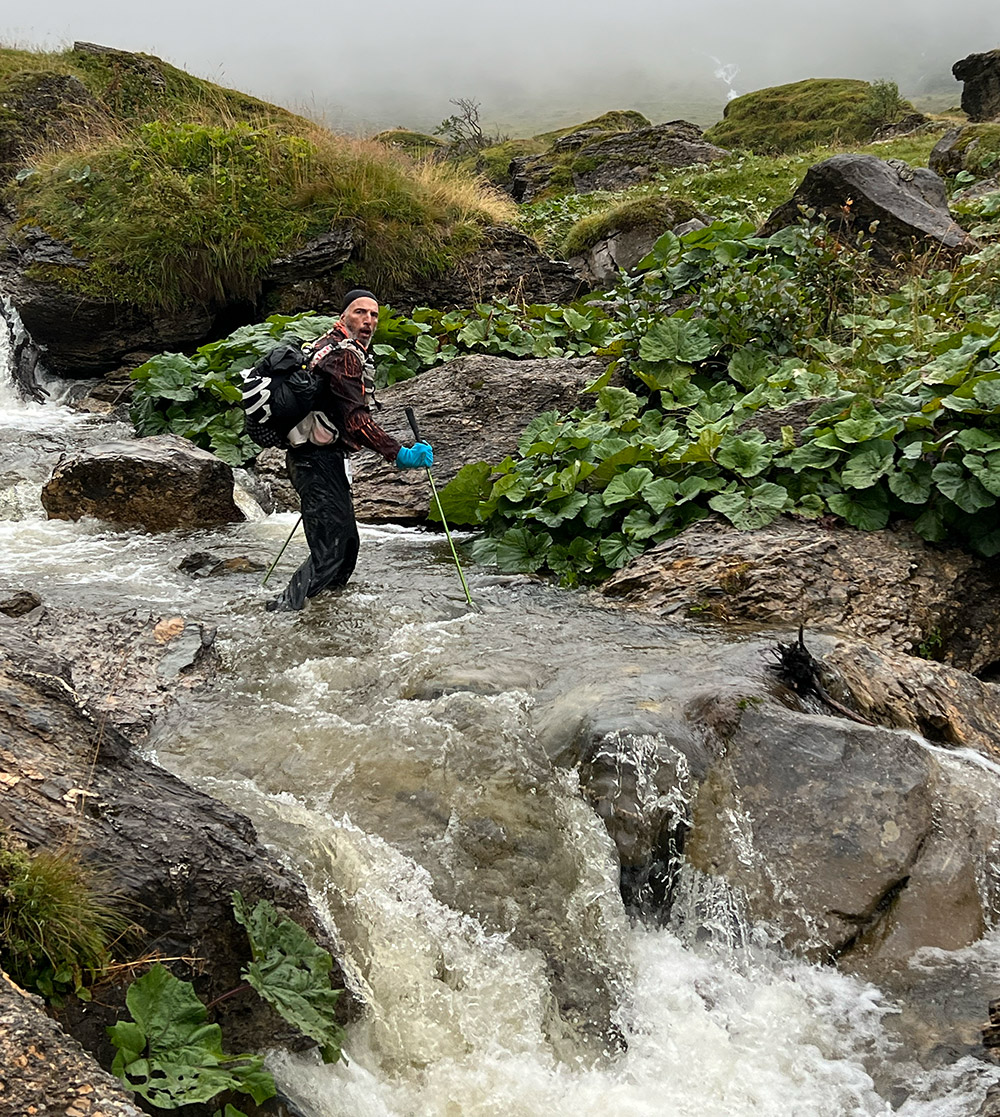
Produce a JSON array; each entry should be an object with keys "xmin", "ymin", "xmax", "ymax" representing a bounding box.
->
[{"xmin": 267, "ymin": 290, "xmax": 434, "ymax": 611}]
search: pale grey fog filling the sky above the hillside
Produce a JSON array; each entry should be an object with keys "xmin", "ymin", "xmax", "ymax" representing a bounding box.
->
[{"xmin": 0, "ymin": 0, "xmax": 1000, "ymax": 135}]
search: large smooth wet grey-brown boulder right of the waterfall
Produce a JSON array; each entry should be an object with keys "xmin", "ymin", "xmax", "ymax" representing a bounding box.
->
[{"xmin": 685, "ymin": 707, "xmax": 934, "ymax": 957}]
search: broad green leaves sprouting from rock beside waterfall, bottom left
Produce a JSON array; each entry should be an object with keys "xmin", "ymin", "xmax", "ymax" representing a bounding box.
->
[{"xmin": 108, "ymin": 891, "xmax": 343, "ymax": 1117}]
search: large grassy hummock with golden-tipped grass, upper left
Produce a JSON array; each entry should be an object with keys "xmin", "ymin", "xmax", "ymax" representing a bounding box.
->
[{"xmin": 0, "ymin": 44, "xmax": 514, "ymax": 312}]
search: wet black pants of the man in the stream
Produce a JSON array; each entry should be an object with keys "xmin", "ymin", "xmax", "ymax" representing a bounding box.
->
[{"xmin": 268, "ymin": 443, "xmax": 361, "ymax": 610}]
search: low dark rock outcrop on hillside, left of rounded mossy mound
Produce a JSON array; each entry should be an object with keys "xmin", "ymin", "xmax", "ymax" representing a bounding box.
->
[{"xmin": 509, "ymin": 121, "xmax": 728, "ymax": 202}]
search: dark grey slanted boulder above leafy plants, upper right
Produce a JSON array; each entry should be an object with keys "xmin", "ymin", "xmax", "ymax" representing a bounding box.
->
[{"xmin": 761, "ymin": 154, "xmax": 975, "ymax": 260}]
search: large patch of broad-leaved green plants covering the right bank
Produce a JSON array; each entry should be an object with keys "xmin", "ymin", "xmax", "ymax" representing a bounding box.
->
[{"xmin": 431, "ymin": 212, "xmax": 1000, "ymax": 585}]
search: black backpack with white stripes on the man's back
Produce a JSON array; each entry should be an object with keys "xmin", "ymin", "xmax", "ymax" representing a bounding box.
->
[{"xmin": 240, "ymin": 337, "xmax": 316, "ymax": 447}]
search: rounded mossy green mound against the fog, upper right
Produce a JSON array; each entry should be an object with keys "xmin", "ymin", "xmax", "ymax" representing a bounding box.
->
[{"xmin": 705, "ymin": 78, "xmax": 914, "ymax": 153}]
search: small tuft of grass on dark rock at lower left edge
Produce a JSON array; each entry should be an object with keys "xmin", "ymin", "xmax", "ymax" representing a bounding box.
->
[{"xmin": 0, "ymin": 834, "xmax": 125, "ymax": 1000}]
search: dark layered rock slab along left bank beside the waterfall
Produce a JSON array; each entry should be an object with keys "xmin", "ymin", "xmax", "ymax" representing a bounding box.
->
[{"xmin": 0, "ymin": 610, "xmax": 344, "ymax": 1067}]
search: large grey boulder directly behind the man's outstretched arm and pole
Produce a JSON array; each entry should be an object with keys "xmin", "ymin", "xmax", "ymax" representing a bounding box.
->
[{"xmin": 353, "ymin": 355, "xmax": 604, "ymax": 523}]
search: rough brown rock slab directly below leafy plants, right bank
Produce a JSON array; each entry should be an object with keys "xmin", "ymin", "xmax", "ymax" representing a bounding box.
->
[{"xmin": 603, "ymin": 519, "xmax": 1000, "ymax": 675}]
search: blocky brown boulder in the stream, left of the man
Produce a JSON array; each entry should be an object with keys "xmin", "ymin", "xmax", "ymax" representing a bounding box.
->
[{"xmin": 41, "ymin": 435, "xmax": 247, "ymax": 532}]
